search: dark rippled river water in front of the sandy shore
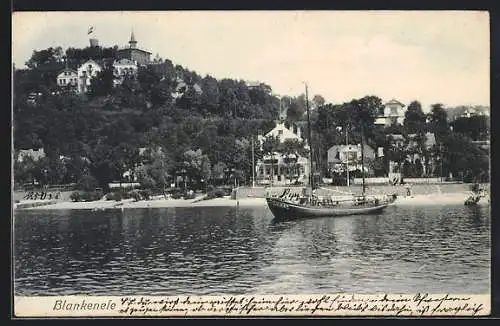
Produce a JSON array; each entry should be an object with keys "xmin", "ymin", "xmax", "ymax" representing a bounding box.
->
[{"xmin": 14, "ymin": 205, "xmax": 490, "ymax": 295}]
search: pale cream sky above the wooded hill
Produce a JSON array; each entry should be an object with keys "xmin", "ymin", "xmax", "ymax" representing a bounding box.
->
[{"xmin": 12, "ymin": 11, "xmax": 490, "ymax": 111}]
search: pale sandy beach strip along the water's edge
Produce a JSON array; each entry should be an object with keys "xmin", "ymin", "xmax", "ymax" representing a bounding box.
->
[{"xmin": 14, "ymin": 192, "xmax": 490, "ymax": 211}]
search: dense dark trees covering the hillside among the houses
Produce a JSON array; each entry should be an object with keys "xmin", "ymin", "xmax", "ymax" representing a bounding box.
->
[{"xmin": 13, "ymin": 47, "xmax": 489, "ymax": 189}]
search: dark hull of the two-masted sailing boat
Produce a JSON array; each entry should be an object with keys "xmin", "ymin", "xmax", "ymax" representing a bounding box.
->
[{"xmin": 266, "ymin": 198, "xmax": 388, "ymax": 220}]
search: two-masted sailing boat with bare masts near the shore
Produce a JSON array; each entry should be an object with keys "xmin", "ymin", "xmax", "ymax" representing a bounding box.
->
[{"xmin": 266, "ymin": 84, "xmax": 393, "ymax": 220}]
